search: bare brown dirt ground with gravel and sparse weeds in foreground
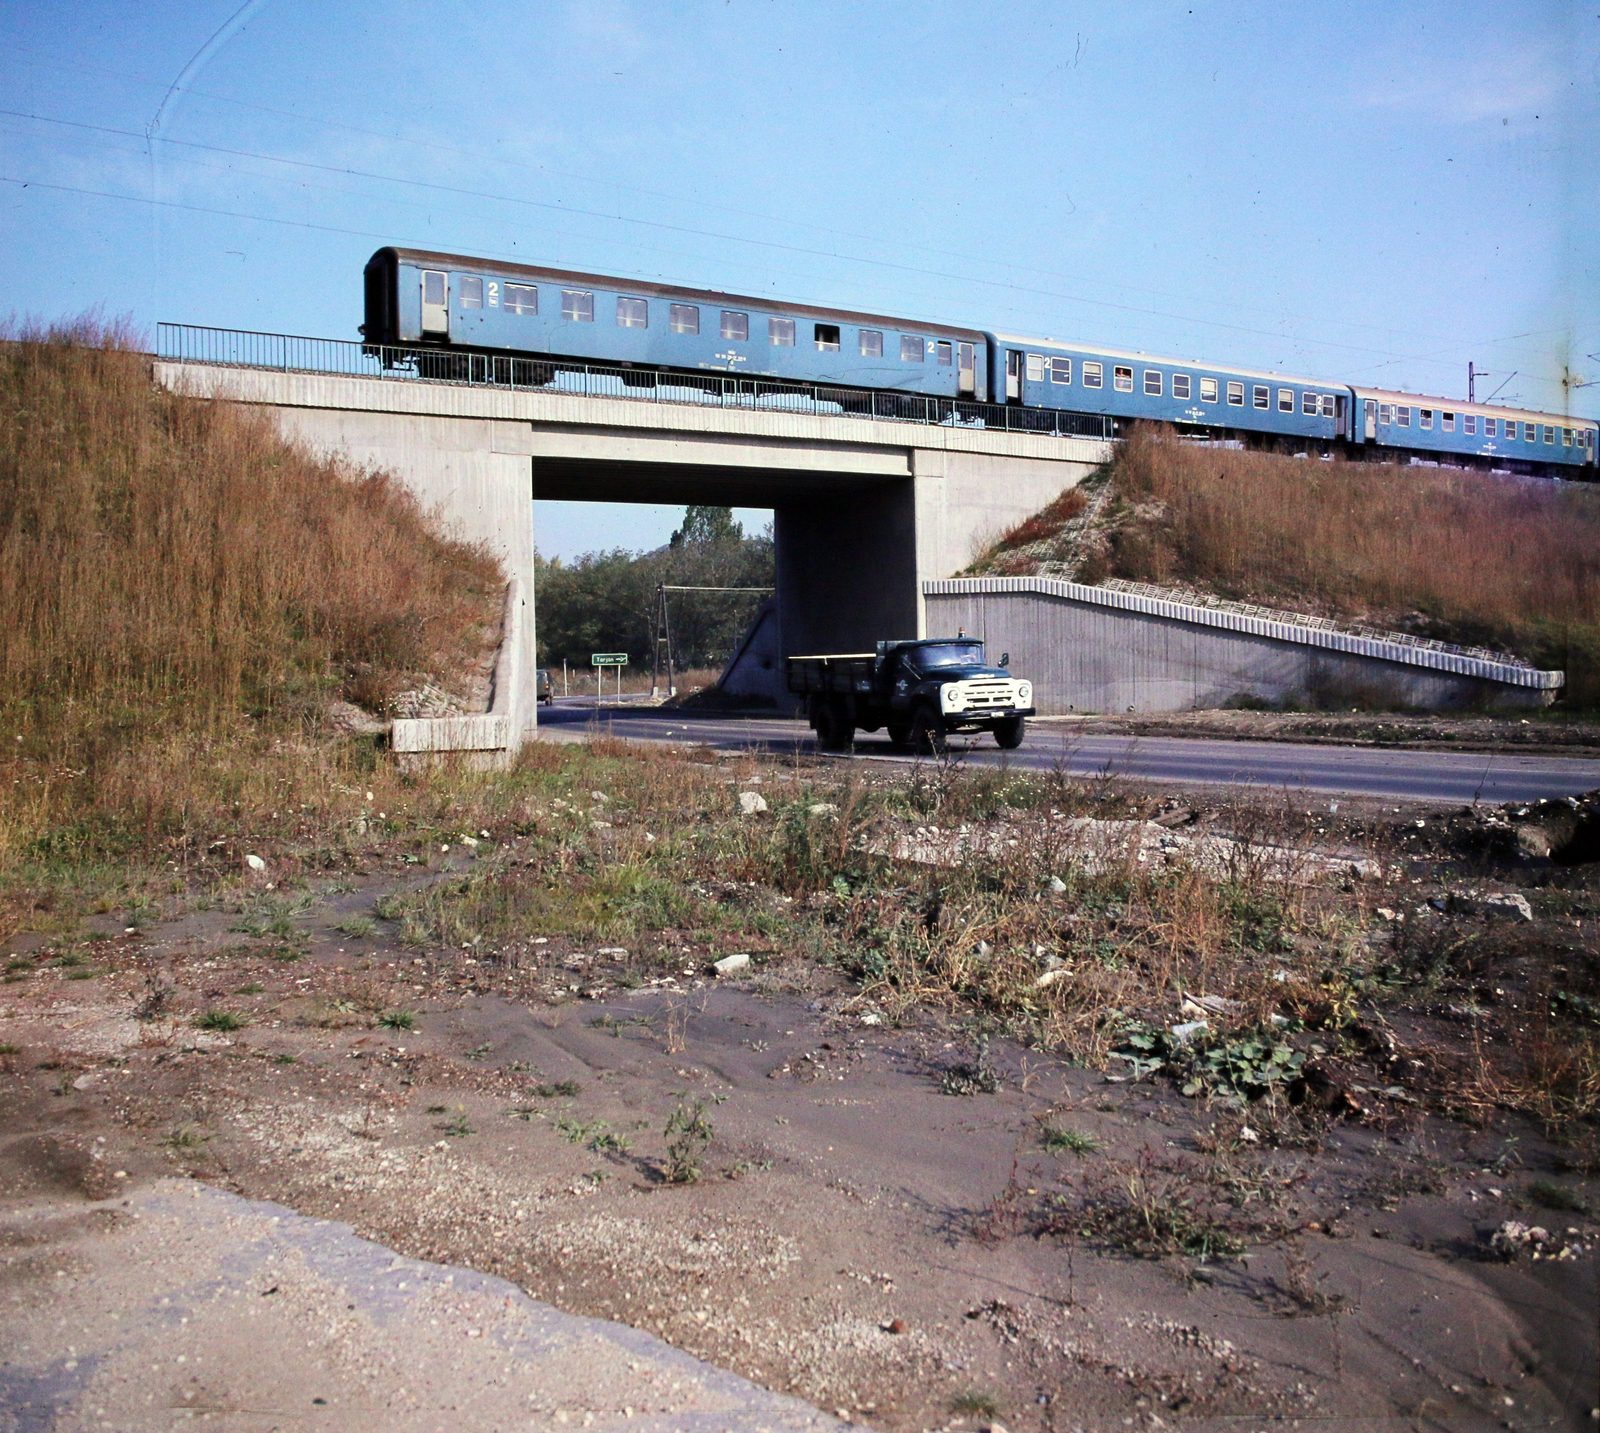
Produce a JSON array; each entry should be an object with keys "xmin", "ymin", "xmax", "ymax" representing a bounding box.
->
[{"xmin": 0, "ymin": 767, "xmax": 1600, "ymax": 1430}]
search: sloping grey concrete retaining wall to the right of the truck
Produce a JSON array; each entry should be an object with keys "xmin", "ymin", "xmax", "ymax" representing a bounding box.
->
[{"xmin": 923, "ymin": 577, "xmax": 1562, "ymax": 715}]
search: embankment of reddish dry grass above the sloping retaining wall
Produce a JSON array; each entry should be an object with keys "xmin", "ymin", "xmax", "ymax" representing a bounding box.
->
[{"xmin": 973, "ymin": 425, "xmax": 1600, "ymax": 707}]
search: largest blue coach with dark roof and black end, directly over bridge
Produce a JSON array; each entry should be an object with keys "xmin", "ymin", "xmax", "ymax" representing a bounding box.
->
[{"xmin": 362, "ymin": 248, "xmax": 989, "ymax": 401}]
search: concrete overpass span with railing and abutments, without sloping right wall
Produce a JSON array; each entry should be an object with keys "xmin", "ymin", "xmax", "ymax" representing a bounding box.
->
[{"xmin": 155, "ymin": 325, "xmax": 1110, "ymax": 745}]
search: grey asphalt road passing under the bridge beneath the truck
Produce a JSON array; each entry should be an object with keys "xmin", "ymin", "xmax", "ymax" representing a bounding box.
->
[{"xmin": 539, "ymin": 699, "xmax": 1600, "ymax": 804}]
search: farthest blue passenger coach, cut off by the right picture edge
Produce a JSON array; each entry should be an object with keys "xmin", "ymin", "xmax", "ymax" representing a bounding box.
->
[{"xmin": 1350, "ymin": 389, "xmax": 1600, "ymax": 470}]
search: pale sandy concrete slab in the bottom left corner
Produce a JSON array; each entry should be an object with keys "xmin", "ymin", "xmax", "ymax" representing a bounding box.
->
[{"xmin": 0, "ymin": 1180, "xmax": 842, "ymax": 1433}]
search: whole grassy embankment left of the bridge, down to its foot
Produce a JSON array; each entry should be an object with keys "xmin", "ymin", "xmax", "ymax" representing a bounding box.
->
[{"xmin": 0, "ymin": 323, "xmax": 502, "ymax": 884}]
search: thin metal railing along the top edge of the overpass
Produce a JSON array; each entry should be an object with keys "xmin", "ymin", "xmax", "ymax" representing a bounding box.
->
[{"xmin": 155, "ymin": 323, "xmax": 1114, "ymax": 438}]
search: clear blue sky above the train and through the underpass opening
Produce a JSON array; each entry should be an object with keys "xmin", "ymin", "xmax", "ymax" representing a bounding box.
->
[{"xmin": 0, "ymin": 0, "xmax": 1600, "ymax": 557}]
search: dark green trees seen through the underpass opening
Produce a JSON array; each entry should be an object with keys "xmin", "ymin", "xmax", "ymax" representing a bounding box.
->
[{"xmin": 534, "ymin": 507, "xmax": 776, "ymax": 670}]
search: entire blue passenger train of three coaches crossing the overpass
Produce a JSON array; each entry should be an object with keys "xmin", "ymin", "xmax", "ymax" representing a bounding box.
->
[{"xmin": 362, "ymin": 248, "xmax": 1600, "ymax": 477}]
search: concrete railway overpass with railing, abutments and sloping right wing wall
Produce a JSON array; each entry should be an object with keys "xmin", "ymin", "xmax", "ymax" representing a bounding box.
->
[{"xmin": 155, "ymin": 325, "xmax": 1562, "ymax": 760}]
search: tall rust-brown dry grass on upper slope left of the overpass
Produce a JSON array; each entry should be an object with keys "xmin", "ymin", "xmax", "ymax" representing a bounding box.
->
[{"xmin": 0, "ymin": 321, "xmax": 502, "ymax": 755}]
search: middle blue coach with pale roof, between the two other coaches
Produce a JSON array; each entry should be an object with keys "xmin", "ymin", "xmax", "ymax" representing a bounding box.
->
[{"xmin": 986, "ymin": 333, "xmax": 1350, "ymax": 445}]
